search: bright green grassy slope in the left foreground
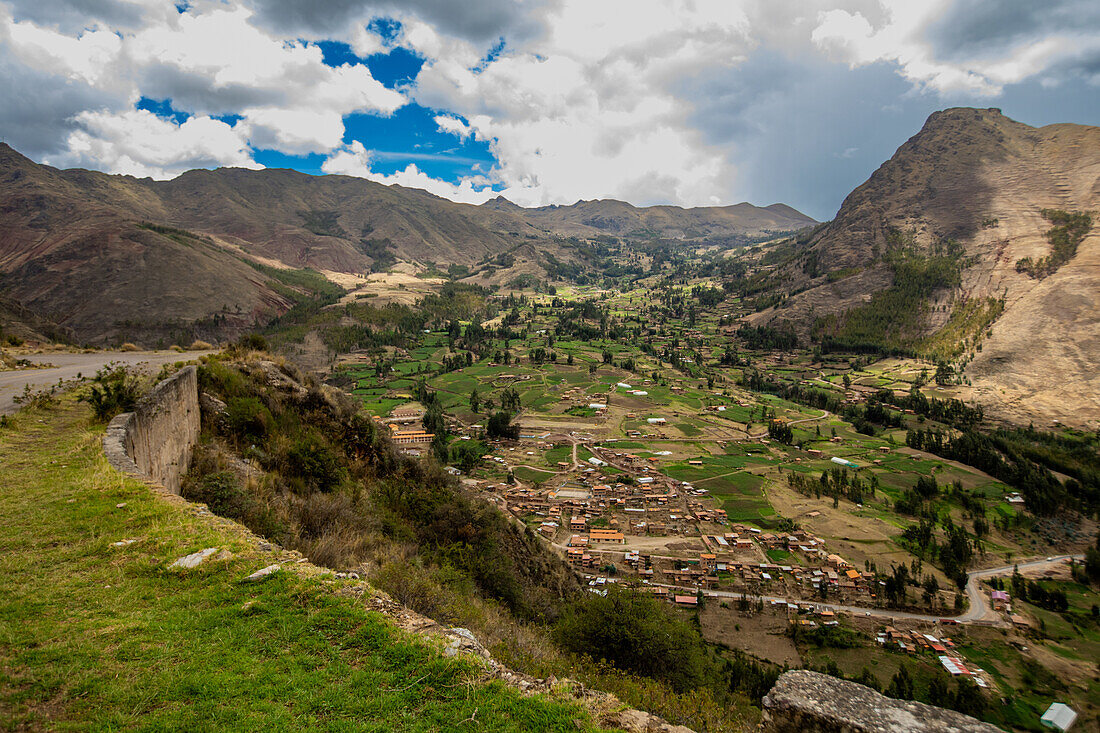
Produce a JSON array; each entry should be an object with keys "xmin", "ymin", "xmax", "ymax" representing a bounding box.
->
[{"xmin": 0, "ymin": 397, "xmax": 594, "ymax": 731}]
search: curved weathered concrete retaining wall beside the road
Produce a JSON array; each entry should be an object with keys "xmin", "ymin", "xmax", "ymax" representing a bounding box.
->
[{"xmin": 103, "ymin": 365, "xmax": 199, "ymax": 494}]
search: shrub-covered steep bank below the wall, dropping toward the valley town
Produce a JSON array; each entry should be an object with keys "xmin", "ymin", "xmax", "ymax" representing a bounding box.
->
[{"xmin": 184, "ymin": 349, "xmax": 777, "ymax": 731}]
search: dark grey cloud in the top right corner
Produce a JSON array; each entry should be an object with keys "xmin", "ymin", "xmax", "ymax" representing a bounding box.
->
[{"xmin": 926, "ymin": 0, "xmax": 1100, "ymax": 61}]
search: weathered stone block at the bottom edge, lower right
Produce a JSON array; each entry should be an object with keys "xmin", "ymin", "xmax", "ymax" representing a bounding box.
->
[{"xmin": 760, "ymin": 669, "xmax": 1001, "ymax": 733}]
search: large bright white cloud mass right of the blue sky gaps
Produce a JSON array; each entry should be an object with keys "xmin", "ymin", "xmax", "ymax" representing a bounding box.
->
[{"xmin": 404, "ymin": 0, "xmax": 751, "ymax": 205}]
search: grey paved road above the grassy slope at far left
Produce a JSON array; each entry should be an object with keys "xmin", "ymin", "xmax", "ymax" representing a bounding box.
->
[{"xmin": 0, "ymin": 351, "xmax": 211, "ymax": 415}]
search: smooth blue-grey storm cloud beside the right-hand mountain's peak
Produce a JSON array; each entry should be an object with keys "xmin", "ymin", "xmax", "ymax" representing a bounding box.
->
[{"xmin": 685, "ymin": 48, "xmax": 939, "ymax": 220}]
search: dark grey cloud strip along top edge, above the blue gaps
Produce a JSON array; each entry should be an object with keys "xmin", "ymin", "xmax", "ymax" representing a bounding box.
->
[{"xmin": 252, "ymin": 0, "xmax": 551, "ymax": 43}]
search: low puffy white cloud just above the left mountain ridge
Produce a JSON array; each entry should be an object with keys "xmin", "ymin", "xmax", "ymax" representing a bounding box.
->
[{"xmin": 45, "ymin": 110, "xmax": 263, "ymax": 179}]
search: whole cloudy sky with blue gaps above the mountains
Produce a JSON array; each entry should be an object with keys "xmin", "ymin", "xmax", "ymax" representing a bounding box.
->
[{"xmin": 0, "ymin": 0, "xmax": 1100, "ymax": 220}]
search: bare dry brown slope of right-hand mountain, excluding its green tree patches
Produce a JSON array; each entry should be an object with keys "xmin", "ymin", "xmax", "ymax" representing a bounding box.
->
[{"xmin": 758, "ymin": 109, "xmax": 1100, "ymax": 426}]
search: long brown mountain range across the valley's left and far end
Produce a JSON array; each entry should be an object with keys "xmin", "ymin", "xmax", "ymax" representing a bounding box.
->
[{"xmin": 0, "ymin": 143, "xmax": 812, "ymax": 346}]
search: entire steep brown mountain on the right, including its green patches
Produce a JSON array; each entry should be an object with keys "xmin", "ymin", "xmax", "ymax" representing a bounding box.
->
[{"xmin": 754, "ymin": 109, "xmax": 1100, "ymax": 427}]
